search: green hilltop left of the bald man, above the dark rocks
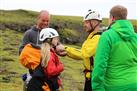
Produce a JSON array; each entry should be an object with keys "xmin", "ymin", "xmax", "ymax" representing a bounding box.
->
[{"xmin": 0, "ymin": 10, "xmax": 38, "ymax": 24}]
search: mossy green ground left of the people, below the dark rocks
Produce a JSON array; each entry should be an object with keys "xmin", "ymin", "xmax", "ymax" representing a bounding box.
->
[{"xmin": 0, "ymin": 29, "xmax": 26, "ymax": 91}]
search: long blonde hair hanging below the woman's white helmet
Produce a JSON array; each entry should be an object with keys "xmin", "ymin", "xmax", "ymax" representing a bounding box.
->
[{"xmin": 41, "ymin": 42, "xmax": 51, "ymax": 67}]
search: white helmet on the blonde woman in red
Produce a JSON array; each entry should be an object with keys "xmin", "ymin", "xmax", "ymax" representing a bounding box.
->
[{"xmin": 39, "ymin": 28, "xmax": 59, "ymax": 41}]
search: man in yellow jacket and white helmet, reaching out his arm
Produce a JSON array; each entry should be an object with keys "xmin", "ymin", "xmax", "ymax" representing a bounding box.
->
[{"xmin": 57, "ymin": 10, "xmax": 102, "ymax": 91}]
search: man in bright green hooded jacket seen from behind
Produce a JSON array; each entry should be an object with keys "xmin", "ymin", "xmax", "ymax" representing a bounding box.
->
[{"xmin": 92, "ymin": 5, "xmax": 137, "ymax": 91}]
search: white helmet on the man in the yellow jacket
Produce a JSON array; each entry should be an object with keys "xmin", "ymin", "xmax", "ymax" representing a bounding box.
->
[{"xmin": 83, "ymin": 9, "xmax": 102, "ymax": 21}]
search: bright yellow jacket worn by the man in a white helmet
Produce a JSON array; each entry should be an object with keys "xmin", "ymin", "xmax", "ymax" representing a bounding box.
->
[{"xmin": 65, "ymin": 32, "xmax": 100, "ymax": 78}]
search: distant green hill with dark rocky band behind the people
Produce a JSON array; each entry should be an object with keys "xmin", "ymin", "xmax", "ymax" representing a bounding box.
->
[{"xmin": 0, "ymin": 9, "xmax": 137, "ymax": 43}]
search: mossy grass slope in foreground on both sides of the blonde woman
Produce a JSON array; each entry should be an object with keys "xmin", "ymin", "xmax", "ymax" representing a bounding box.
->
[{"xmin": 0, "ymin": 29, "xmax": 84, "ymax": 91}]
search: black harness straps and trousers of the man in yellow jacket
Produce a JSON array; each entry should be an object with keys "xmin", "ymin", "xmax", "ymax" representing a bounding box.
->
[{"xmin": 83, "ymin": 32, "xmax": 102, "ymax": 91}]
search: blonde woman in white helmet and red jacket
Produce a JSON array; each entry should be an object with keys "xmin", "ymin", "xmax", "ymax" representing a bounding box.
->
[{"xmin": 27, "ymin": 28, "xmax": 64, "ymax": 91}]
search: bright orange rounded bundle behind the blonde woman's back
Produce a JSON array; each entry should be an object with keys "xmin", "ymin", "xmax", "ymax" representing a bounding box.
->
[{"xmin": 19, "ymin": 44, "xmax": 41, "ymax": 70}]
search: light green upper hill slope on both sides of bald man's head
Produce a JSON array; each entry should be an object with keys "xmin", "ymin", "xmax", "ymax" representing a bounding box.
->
[{"xmin": 0, "ymin": 9, "xmax": 82, "ymax": 30}]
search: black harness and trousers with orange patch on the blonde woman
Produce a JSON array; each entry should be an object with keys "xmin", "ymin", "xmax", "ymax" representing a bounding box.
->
[{"xmin": 27, "ymin": 64, "xmax": 60, "ymax": 91}]
